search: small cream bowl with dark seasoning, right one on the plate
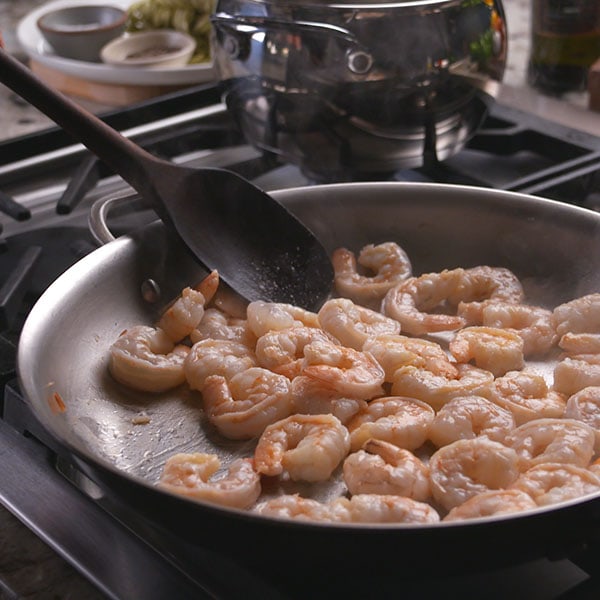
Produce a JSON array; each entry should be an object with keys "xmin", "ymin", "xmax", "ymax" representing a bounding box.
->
[{"xmin": 100, "ymin": 29, "xmax": 196, "ymax": 67}]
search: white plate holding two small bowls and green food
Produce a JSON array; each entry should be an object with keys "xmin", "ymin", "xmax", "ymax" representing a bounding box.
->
[{"xmin": 17, "ymin": 0, "xmax": 215, "ymax": 85}]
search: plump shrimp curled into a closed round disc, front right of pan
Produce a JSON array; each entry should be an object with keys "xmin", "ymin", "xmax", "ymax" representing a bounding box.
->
[{"xmin": 429, "ymin": 437, "xmax": 519, "ymax": 510}]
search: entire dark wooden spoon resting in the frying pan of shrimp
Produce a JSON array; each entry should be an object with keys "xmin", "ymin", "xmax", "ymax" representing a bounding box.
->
[{"xmin": 0, "ymin": 50, "xmax": 333, "ymax": 310}]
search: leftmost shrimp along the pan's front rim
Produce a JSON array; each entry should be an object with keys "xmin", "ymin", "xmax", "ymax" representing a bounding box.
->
[{"xmin": 158, "ymin": 453, "xmax": 261, "ymax": 509}]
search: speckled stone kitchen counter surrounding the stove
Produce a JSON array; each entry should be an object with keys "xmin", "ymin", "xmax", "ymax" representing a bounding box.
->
[{"xmin": 0, "ymin": 0, "xmax": 600, "ymax": 600}]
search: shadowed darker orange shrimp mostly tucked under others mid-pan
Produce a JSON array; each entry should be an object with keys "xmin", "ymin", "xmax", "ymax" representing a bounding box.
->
[{"xmin": 292, "ymin": 375, "xmax": 367, "ymax": 424}]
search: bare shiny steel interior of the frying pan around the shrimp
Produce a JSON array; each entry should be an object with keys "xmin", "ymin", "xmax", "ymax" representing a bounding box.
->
[{"xmin": 18, "ymin": 183, "xmax": 600, "ymax": 528}]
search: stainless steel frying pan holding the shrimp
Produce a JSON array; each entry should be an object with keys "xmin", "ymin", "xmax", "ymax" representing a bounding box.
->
[{"xmin": 18, "ymin": 183, "xmax": 600, "ymax": 573}]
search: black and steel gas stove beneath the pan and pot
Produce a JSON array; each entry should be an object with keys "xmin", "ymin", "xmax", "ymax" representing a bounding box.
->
[{"xmin": 0, "ymin": 85, "xmax": 600, "ymax": 599}]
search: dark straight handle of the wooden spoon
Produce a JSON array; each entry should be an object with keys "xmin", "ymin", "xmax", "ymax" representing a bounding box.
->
[{"xmin": 0, "ymin": 50, "xmax": 163, "ymax": 193}]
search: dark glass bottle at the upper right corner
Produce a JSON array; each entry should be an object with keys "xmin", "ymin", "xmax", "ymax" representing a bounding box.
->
[{"xmin": 528, "ymin": 0, "xmax": 600, "ymax": 94}]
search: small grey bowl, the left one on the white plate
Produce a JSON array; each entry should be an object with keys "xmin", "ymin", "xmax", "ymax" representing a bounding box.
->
[{"xmin": 37, "ymin": 5, "xmax": 127, "ymax": 62}]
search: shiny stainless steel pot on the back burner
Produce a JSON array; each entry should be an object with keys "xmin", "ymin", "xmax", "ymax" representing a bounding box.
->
[{"xmin": 212, "ymin": 0, "xmax": 507, "ymax": 181}]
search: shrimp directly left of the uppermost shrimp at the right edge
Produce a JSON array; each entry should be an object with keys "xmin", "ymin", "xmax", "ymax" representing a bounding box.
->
[{"xmin": 481, "ymin": 302, "xmax": 558, "ymax": 356}]
